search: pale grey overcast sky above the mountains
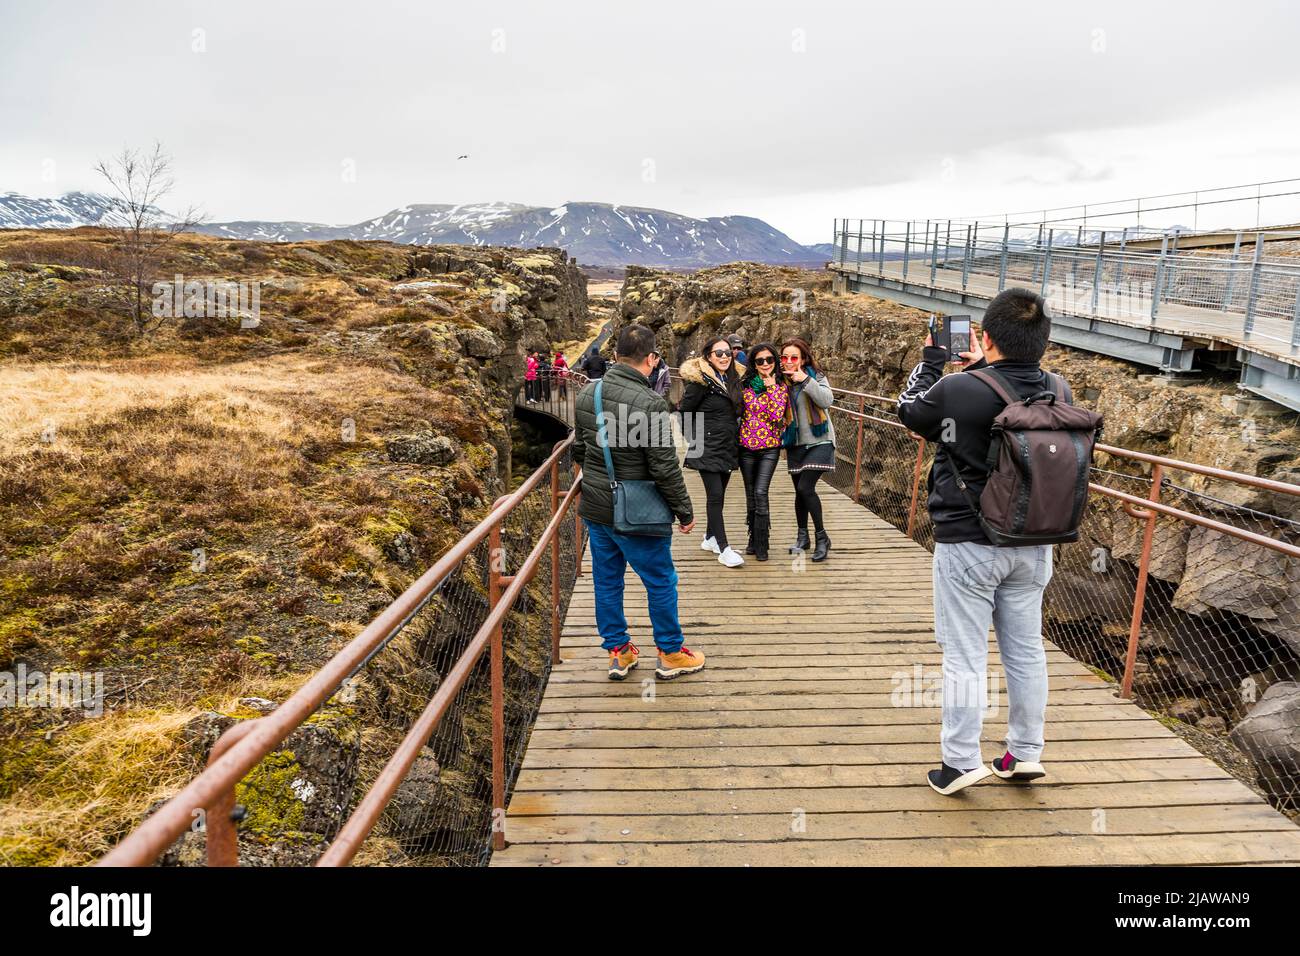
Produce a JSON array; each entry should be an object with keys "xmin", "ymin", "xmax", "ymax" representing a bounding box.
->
[{"xmin": 0, "ymin": 0, "xmax": 1300, "ymax": 242}]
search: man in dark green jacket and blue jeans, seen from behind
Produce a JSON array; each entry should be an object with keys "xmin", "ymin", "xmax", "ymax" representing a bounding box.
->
[{"xmin": 573, "ymin": 325, "xmax": 705, "ymax": 680}]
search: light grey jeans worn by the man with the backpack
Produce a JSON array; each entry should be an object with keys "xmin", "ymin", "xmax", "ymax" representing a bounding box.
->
[{"xmin": 933, "ymin": 541, "xmax": 1052, "ymax": 770}]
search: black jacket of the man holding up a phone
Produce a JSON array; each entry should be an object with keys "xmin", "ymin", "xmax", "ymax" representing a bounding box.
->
[{"xmin": 898, "ymin": 346, "xmax": 1074, "ymax": 544}]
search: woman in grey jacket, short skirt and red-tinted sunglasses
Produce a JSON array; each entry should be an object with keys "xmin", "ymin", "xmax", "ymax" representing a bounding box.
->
[{"xmin": 781, "ymin": 338, "xmax": 835, "ymax": 561}]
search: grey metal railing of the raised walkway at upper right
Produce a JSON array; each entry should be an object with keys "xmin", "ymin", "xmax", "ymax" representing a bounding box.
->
[{"xmin": 835, "ymin": 220, "xmax": 1300, "ymax": 352}]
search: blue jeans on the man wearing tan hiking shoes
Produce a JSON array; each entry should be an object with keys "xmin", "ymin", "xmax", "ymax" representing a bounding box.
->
[{"xmin": 586, "ymin": 522, "xmax": 684, "ymax": 654}]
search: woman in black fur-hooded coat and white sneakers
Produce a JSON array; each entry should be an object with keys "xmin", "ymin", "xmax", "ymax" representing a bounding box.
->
[{"xmin": 677, "ymin": 338, "xmax": 745, "ymax": 567}]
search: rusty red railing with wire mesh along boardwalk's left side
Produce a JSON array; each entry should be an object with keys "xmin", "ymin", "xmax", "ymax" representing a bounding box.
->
[{"xmin": 101, "ymin": 437, "xmax": 584, "ymax": 866}]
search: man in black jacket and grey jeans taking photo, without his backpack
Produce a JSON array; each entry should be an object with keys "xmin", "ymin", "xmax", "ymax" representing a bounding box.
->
[{"xmin": 898, "ymin": 289, "xmax": 1071, "ymax": 795}]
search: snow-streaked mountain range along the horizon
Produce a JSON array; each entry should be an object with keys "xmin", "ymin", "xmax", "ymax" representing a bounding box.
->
[{"xmin": 0, "ymin": 193, "xmax": 827, "ymax": 268}]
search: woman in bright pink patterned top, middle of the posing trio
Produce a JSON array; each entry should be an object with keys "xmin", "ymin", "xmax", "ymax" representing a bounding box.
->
[{"xmin": 740, "ymin": 342, "xmax": 790, "ymax": 561}]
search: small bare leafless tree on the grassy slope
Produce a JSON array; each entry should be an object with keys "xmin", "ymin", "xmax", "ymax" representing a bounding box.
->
[{"xmin": 95, "ymin": 142, "xmax": 203, "ymax": 336}]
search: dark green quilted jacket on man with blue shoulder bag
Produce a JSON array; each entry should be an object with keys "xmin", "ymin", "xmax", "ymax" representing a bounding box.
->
[{"xmin": 573, "ymin": 362, "xmax": 694, "ymax": 524}]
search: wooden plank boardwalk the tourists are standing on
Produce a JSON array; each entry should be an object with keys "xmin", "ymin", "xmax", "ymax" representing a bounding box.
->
[{"xmin": 493, "ymin": 466, "xmax": 1300, "ymax": 866}]
